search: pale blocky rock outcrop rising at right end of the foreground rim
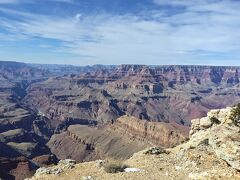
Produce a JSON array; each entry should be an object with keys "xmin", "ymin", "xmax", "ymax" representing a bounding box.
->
[{"xmin": 187, "ymin": 107, "xmax": 240, "ymax": 171}]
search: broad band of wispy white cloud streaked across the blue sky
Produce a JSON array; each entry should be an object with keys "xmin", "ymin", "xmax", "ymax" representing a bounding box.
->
[{"xmin": 0, "ymin": 0, "xmax": 240, "ymax": 64}]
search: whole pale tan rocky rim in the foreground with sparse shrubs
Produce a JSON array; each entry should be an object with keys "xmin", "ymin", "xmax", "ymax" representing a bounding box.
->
[{"xmin": 28, "ymin": 108, "xmax": 240, "ymax": 180}]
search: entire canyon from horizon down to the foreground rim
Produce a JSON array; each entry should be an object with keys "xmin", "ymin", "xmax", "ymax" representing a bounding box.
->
[{"xmin": 0, "ymin": 62, "xmax": 240, "ymax": 179}]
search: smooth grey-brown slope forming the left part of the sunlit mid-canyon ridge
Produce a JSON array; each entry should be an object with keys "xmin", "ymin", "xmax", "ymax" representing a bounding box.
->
[{"xmin": 48, "ymin": 125, "xmax": 149, "ymax": 162}]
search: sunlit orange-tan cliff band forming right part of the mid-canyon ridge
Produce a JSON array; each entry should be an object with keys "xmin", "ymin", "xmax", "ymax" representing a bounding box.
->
[{"xmin": 115, "ymin": 115, "xmax": 188, "ymax": 148}]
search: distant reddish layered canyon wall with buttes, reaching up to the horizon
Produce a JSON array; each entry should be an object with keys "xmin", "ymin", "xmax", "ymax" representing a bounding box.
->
[{"xmin": 25, "ymin": 65, "xmax": 240, "ymax": 129}]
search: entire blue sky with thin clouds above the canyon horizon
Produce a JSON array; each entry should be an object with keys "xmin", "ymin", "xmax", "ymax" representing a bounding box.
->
[{"xmin": 0, "ymin": 0, "xmax": 240, "ymax": 65}]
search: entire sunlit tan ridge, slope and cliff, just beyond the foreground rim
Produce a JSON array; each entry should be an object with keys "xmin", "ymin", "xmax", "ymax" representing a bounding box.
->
[{"xmin": 48, "ymin": 116, "xmax": 187, "ymax": 162}]
